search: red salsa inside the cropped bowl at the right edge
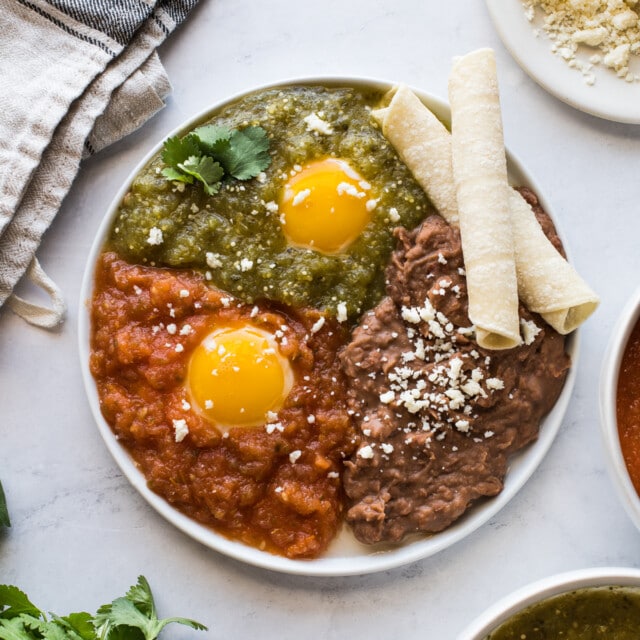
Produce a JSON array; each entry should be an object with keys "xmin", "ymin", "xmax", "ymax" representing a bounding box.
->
[{"xmin": 616, "ymin": 322, "xmax": 640, "ymax": 494}]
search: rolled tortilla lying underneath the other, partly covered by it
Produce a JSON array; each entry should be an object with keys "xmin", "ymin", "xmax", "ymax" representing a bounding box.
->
[{"xmin": 373, "ymin": 79, "xmax": 599, "ymax": 334}]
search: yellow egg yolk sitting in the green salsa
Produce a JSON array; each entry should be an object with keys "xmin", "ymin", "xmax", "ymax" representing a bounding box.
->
[{"xmin": 280, "ymin": 158, "xmax": 373, "ymax": 254}]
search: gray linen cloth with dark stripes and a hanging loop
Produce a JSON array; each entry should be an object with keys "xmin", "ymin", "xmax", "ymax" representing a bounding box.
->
[{"xmin": 0, "ymin": 0, "xmax": 197, "ymax": 328}]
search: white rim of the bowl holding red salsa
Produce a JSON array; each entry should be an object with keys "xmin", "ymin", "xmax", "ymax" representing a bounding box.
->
[{"xmin": 600, "ymin": 287, "xmax": 640, "ymax": 529}]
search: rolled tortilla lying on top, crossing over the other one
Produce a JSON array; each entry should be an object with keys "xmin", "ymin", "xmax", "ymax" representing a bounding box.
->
[{"xmin": 449, "ymin": 49, "xmax": 521, "ymax": 349}]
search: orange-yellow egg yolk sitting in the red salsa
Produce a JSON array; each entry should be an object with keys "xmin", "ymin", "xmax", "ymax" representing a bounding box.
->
[{"xmin": 188, "ymin": 324, "xmax": 293, "ymax": 431}]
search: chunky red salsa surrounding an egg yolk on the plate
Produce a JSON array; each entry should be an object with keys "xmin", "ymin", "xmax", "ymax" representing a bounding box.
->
[{"xmin": 90, "ymin": 252, "xmax": 353, "ymax": 558}]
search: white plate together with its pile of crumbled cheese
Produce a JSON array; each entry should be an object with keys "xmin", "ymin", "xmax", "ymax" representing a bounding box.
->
[{"xmin": 486, "ymin": 0, "xmax": 640, "ymax": 124}]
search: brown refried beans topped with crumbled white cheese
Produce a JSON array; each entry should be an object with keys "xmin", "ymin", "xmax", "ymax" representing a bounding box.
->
[{"xmin": 342, "ymin": 191, "xmax": 570, "ymax": 544}]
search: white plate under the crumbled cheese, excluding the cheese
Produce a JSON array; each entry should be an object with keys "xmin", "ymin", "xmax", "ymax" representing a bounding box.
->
[{"xmin": 486, "ymin": 0, "xmax": 640, "ymax": 124}]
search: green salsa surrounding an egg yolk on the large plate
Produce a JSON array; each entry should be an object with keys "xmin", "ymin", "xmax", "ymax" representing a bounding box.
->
[{"xmin": 109, "ymin": 86, "xmax": 434, "ymax": 318}]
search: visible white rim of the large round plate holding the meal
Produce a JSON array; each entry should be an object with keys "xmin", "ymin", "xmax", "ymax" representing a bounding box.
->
[{"xmin": 78, "ymin": 78, "xmax": 578, "ymax": 576}]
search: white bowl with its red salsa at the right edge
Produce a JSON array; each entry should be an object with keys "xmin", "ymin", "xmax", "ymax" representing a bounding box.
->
[{"xmin": 600, "ymin": 287, "xmax": 640, "ymax": 529}]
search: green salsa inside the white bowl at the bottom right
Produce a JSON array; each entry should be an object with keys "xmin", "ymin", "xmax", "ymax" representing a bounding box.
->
[{"xmin": 485, "ymin": 586, "xmax": 640, "ymax": 640}]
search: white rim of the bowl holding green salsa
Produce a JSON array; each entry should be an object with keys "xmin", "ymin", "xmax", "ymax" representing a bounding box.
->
[{"xmin": 457, "ymin": 567, "xmax": 640, "ymax": 640}]
